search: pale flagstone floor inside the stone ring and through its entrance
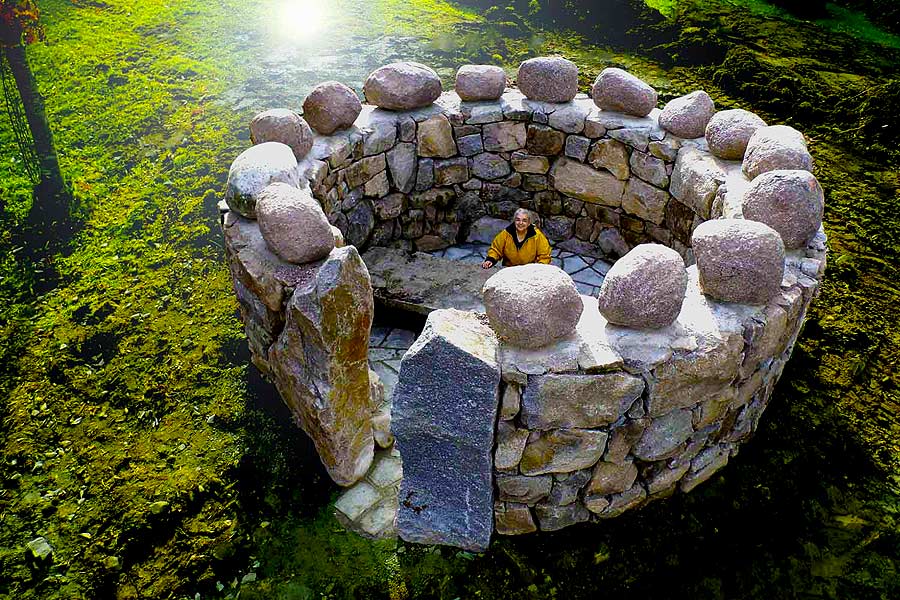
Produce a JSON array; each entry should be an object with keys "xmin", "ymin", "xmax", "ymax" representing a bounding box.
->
[{"xmin": 334, "ymin": 242, "xmax": 612, "ymax": 538}]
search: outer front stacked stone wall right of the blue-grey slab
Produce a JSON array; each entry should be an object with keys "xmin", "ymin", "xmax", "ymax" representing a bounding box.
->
[{"xmin": 494, "ymin": 246, "xmax": 824, "ymax": 535}]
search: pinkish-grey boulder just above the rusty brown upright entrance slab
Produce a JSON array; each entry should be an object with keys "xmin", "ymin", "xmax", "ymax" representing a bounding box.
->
[{"xmin": 256, "ymin": 183, "xmax": 334, "ymax": 264}]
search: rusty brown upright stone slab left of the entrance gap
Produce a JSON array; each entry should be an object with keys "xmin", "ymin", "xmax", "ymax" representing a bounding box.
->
[{"xmin": 269, "ymin": 246, "xmax": 375, "ymax": 486}]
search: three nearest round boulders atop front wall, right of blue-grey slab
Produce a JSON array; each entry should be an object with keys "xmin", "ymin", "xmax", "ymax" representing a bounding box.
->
[{"xmin": 483, "ymin": 214, "xmax": 808, "ymax": 348}]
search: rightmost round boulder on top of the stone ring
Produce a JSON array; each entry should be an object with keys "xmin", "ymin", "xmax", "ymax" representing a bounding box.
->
[{"xmin": 741, "ymin": 169, "xmax": 825, "ymax": 250}]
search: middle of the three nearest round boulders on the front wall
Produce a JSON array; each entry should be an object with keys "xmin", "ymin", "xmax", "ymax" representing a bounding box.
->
[{"xmin": 598, "ymin": 244, "xmax": 687, "ymax": 329}]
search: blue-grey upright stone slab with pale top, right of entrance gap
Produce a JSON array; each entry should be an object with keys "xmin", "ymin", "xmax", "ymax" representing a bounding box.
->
[{"xmin": 391, "ymin": 309, "xmax": 500, "ymax": 552}]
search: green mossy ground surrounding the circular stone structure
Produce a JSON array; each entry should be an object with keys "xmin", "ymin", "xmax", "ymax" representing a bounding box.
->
[{"xmin": 0, "ymin": 0, "xmax": 900, "ymax": 599}]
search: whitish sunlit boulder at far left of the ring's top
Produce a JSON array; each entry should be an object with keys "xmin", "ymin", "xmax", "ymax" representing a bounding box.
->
[{"xmin": 225, "ymin": 142, "xmax": 300, "ymax": 219}]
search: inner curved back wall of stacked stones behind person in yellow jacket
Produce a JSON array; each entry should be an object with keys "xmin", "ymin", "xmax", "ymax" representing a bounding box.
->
[{"xmin": 301, "ymin": 89, "xmax": 712, "ymax": 256}]
